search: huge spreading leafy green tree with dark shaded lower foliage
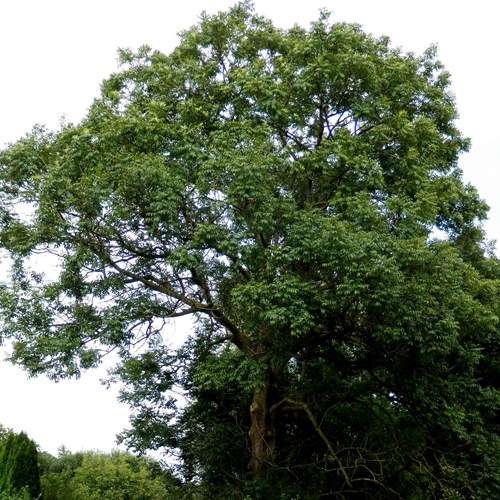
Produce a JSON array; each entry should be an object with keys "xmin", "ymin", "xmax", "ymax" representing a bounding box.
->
[{"xmin": 0, "ymin": 3, "xmax": 500, "ymax": 499}]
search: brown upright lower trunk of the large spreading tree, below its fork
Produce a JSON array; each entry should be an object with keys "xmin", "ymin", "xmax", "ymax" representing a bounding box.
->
[{"xmin": 248, "ymin": 383, "xmax": 276, "ymax": 479}]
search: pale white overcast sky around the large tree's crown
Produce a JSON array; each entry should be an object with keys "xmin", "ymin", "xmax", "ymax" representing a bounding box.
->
[{"xmin": 0, "ymin": 0, "xmax": 500, "ymax": 453}]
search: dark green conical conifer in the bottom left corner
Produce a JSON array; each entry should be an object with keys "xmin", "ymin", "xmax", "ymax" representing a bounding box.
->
[{"xmin": 0, "ymin": 432, "xmax": 40, "ymax": 498}]
